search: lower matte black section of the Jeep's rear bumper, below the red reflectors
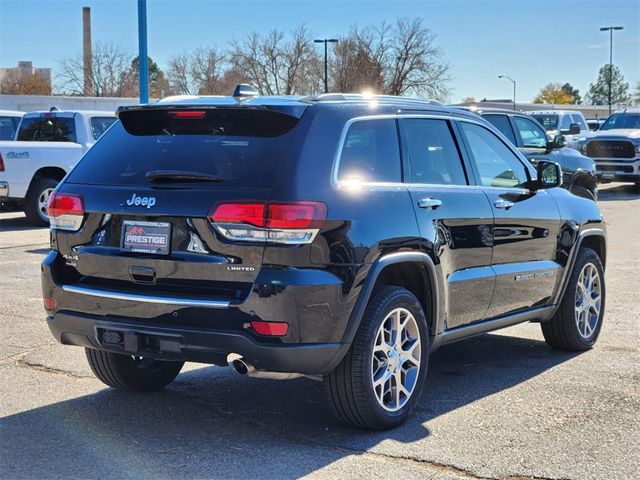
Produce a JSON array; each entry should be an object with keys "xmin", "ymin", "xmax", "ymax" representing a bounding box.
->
[{"xmin": 47, "ymin": 311, "xmax": 349, "ymax": 375}]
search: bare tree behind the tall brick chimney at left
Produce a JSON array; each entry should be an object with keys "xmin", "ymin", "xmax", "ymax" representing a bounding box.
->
[{"xmin": 59, "ymin": 42, "xmax": 133, "ymax": 97}]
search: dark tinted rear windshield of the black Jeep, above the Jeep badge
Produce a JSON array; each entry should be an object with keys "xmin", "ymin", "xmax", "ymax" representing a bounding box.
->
[{"xmin": 67, "ymin": 109, "xmax": 298, "ymax": 187}]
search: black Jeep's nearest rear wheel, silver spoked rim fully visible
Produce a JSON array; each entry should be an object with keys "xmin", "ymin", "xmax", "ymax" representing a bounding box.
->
[{"xmin": 325, "ymin": 287, "xmax": 429, "ymax": 430}]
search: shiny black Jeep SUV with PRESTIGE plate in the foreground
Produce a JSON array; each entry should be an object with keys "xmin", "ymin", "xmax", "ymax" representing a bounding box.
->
[{"xmin": 42, "ymin": 94, "xmax": 606, "ymax": 429}]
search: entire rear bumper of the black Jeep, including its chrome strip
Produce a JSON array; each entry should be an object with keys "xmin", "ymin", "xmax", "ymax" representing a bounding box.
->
[{"xmin": 42, "ymin": 251, "xmax": 355, "ymax": 375}]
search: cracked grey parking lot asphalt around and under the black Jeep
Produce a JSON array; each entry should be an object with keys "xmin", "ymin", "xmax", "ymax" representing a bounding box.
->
[{"xmin": 0, "ymin": 184, "xmax": 640, "ymax": 479}]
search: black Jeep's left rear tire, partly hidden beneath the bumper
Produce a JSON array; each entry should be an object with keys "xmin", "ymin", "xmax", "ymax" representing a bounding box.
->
[{"xmin": 85, "ymin": 348, "xmax": 184, "ymax": 392}]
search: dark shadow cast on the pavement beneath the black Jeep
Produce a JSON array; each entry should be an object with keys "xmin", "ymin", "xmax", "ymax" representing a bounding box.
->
[{"xmin": 0, "ymin": 334, "xmax": 576, "ymax": 478}]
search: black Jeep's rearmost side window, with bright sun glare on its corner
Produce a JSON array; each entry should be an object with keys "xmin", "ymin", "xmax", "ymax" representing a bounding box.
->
[{"xmin": 338, "ymin": 119, "xmax": 402, "ymax": 183}]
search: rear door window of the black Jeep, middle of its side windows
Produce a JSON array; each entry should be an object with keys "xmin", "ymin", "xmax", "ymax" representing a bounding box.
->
[{"xmin": 401, "ymin": 118, "xmax": 467, "ymax": 185}]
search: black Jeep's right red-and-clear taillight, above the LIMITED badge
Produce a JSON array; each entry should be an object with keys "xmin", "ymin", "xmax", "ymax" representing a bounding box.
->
[{"xmin": 208, "ymin": 202, "xmax": 327, "ymax": 244}]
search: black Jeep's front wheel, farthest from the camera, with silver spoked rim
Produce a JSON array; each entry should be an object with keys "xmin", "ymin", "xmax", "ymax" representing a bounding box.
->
[{"xmin": 541, "ymin": 248, "xmax": 605, "ymax": 351}]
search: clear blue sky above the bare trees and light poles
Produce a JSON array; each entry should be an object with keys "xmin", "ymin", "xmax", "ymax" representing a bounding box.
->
[{"xmin": 0, "ymin": 0, "xmax": 640, "ymax": 101}]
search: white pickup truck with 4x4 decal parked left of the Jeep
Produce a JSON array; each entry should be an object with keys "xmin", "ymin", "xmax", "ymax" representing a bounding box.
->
[{"xmin": 0, "ymin": 110, "xmax": 117, "ymax": 225}]
